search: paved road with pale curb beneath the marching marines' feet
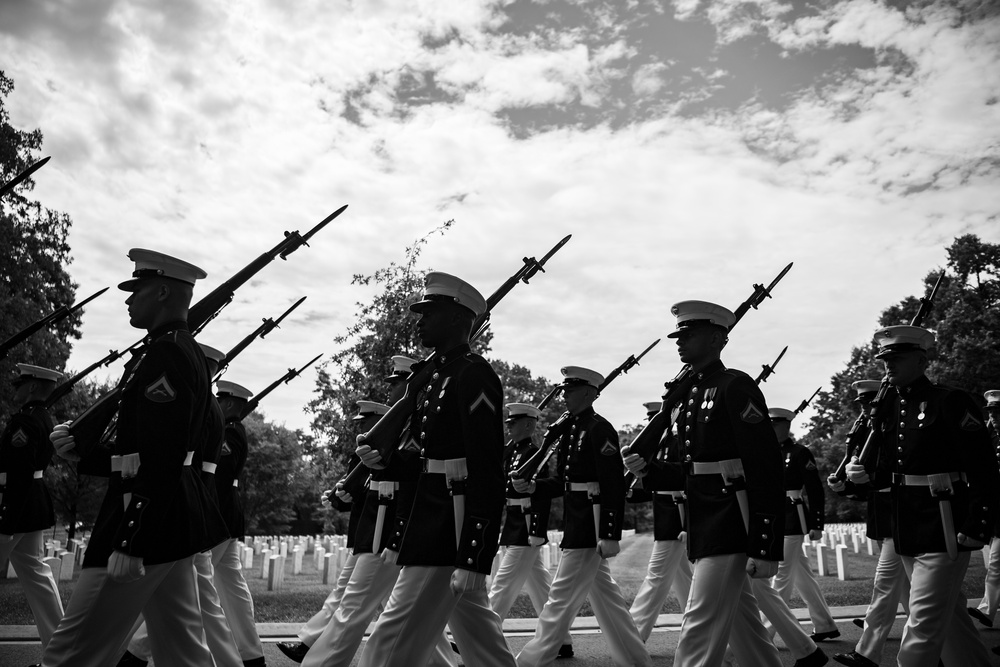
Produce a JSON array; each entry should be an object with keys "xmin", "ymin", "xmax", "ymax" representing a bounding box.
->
[{"xmin": 7, "ymin": 607, "xmax": 1000, "ymax": 667}]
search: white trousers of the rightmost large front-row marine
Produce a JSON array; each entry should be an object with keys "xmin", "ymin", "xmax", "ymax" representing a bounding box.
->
[{"xmin": 896, "ymin": 551, "xmax": 990, "ymax": 667}]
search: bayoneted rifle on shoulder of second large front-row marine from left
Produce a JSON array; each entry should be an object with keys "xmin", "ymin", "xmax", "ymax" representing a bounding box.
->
[{"xmin": 341, "ymin": 234, "xmax": 572, "ymax": 486}]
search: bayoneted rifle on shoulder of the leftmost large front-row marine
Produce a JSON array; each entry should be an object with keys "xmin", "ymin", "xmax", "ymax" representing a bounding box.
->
[{"xmin": 69, "ymin": 211, "xmax": 347, "ymax": 455}]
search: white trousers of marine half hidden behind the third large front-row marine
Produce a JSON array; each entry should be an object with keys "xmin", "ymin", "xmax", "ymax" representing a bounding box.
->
[{"xmin": 629, "ymin": 540, "xmax": 691, "ymax": 641}]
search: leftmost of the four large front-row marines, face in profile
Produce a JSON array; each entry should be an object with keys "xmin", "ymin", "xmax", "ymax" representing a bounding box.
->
[{"xmin": 42, "ymin": 249, "xmax": 213, "ymax": 667}]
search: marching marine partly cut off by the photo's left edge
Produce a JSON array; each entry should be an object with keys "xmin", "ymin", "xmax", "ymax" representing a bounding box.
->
[{"xmin": 0, "ymin": 364, "xmax": 63, "ymax": 649}]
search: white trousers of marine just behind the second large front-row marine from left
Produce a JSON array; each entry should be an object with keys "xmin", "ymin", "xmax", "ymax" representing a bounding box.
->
[{"xmin": 302, "ymin": 554, "xmax": 456, "ymax": 667}]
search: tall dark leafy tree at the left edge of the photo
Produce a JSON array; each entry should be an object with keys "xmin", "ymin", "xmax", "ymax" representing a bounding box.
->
[{"xmin": 0, "ymin": 71, "xmax": 81, "ymax": 415}]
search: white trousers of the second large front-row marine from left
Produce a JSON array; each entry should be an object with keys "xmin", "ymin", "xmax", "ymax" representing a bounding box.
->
[{"xmin": 358, "ymin": 565, "xmax": 514, "ymax": 667}]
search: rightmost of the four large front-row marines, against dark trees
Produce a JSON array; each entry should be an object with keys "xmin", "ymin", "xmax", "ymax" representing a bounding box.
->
[{"xmin": 847, "ymin": 325, "xmax": 1000, "ymax": 667}]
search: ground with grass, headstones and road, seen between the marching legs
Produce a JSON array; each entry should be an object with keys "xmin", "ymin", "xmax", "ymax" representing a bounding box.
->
[{"xmin": 0, "ymin": 524, "xmax": 1000, "ymax": 667}]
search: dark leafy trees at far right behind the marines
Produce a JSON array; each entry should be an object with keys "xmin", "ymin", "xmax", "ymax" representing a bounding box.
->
[{"xmin": 802, "ymin": 234, "xmax": 1000, "ymax": 521}]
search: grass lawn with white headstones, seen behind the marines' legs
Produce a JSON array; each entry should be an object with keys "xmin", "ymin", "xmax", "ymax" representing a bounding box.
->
[{"xmin": 0, "ymin": 533, "xmax": 986, "ymax": 625}]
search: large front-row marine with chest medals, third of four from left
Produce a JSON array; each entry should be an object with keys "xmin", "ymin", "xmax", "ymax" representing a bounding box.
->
[{"xmin": 624, "ymin": 301, "xmax": 784, "ymax": 667}]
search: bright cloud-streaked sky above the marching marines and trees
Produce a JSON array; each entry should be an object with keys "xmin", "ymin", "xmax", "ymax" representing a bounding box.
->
[{"xmin": 0, "ymin": 0, "xmax": 1000, "ymax": 432}]
